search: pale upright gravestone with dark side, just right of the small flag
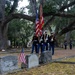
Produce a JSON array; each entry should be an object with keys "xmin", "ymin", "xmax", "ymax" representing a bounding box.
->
[{"xmin": 21, "ymin": 54, "xmax": 39, "ymax": 68}]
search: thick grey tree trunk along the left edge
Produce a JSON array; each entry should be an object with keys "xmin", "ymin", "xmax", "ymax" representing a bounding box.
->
[{"xmin": 0, "ymin": 0, "xmax": 7, "ymax": 50}]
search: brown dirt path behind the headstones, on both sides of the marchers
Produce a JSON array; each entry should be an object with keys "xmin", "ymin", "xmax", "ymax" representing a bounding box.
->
[{"xmin": 0, "ymin": 47, "xmax": 75, "ymax": 59}]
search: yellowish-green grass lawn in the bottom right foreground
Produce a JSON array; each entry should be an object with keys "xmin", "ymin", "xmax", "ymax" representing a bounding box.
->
[{"xmin": 7, "ymin": 58, "xmax": 75, "ymax": 75}]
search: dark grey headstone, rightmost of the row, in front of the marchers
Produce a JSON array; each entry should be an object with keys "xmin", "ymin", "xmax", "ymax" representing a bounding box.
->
[{"xmin": 39, "ymin": 51, "xmax": 52, "ymax": 64}]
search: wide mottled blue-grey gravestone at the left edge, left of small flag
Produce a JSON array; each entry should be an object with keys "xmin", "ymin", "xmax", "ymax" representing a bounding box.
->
[{"xmin": 0, "ymin": 56, "xmax": 18, "ymax": 74}]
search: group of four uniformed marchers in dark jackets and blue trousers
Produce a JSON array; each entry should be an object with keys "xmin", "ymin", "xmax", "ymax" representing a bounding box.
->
[{"xmin": 31, "ymin": 31, "xmax": 55, "ymax": 55}]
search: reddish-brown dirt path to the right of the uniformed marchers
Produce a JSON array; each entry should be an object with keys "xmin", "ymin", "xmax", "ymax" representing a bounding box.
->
[{"xmin": 52, "ymin": 48, "xmax": 75, "ymax": 59}]
